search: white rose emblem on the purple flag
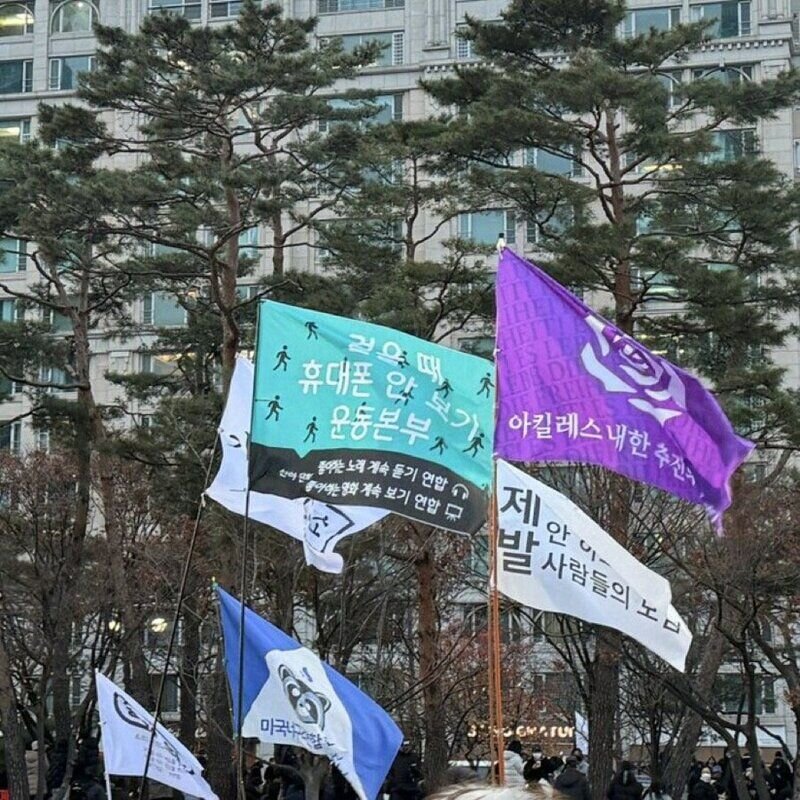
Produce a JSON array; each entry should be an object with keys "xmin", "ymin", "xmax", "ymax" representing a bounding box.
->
[{"xmin": 581, "ymin": 314, "xmax": 686, "ymax": 425}]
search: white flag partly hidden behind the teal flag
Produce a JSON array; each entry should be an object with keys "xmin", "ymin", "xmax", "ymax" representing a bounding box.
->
[{"xmin": 206, "ymin": 358, "xmax": 388, "ymax": 572}]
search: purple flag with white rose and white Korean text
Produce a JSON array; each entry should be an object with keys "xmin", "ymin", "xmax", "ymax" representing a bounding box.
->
[{"xmin": 495, "ymin": 249, "xmax": 755, "ymax": 523}]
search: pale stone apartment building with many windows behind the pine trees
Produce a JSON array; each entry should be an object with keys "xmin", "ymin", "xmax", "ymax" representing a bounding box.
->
[{"xmin": 0, "ymin": 0, "xmax": 800, "ymax": 748}]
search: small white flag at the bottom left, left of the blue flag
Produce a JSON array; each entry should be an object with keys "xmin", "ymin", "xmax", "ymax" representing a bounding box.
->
[{"xmin": 95, "ymin": 672, "xmax": 218, "ymax": 800}]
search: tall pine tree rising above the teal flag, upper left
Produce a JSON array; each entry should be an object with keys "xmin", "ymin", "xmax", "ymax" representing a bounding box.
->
[{"xmin": 48, "ymin": 0, "xmax": 377, "ymax": 394}]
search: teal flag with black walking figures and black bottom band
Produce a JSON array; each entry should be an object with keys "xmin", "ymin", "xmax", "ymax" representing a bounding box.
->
[{"xmin": 250, "ymin": 301, "xmax": 494, "ymax": 533}]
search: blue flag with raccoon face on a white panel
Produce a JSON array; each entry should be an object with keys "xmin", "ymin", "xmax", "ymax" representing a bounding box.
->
[{"xmin": 217, "ymin": 587, "xmax": 403, "ymax": 800}]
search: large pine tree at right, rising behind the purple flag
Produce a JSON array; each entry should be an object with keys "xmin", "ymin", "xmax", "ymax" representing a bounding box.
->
[{"xmin": 427, "ymin": 0, "xmax": 800, "ymax": 797}]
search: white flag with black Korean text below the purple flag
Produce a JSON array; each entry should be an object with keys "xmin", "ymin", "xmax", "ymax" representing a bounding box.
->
[{"xmin": 497, "ymin": 459, "xmax": 692, "ymax": 672}]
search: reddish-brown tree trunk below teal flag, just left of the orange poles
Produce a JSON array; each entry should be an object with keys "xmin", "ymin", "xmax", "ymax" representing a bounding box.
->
[{"xmin": 412, "ymin": 526, "xmax": 449, "ymax": 794}]
